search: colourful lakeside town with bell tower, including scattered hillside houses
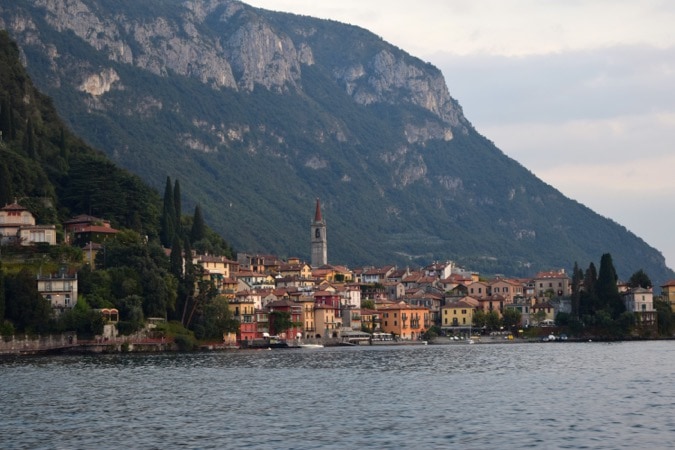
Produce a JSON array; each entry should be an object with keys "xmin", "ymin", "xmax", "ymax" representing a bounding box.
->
[{"xmin": 0, "ymin": 199, "xmax": 675, "ymax": 356}]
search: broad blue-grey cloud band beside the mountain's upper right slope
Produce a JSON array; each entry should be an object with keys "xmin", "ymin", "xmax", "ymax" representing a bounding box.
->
[{"xmin": 428, "ymin": 46, "xmax": 675, "ymax": 125}]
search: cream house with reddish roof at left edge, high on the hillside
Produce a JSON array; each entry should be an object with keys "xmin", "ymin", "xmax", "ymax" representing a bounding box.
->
[{"xmin": 0, "ymin": 200, "xmax": 56, "ymax": 245}]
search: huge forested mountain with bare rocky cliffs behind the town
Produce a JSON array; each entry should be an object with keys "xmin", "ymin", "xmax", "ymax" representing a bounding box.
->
[{"xmin": 0, "ymin": 0, "xmax": 673, "ymax": 283}]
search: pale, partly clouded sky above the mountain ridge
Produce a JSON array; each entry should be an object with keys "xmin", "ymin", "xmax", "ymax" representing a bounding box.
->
[{"xmin": 244, "ymin": 0, "xmax": 675, "ymax": 268}]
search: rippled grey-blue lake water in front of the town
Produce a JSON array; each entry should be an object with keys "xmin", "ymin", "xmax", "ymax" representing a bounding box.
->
[{"xmin": 0, "ymin": 341, "xmax": 675, "ymax": 449}]
